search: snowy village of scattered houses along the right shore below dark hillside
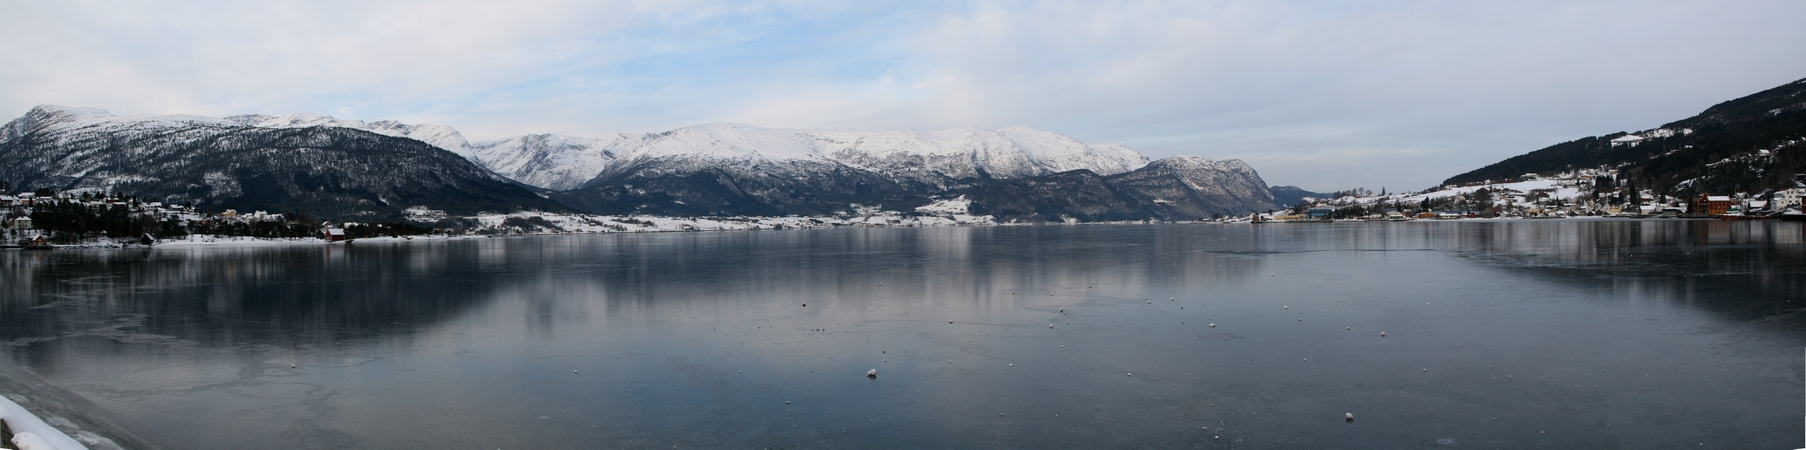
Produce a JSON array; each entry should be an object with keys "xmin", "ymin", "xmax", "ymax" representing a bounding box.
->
[{"xmin": 1256, "ymin": 168, "xmax": 1806, "ymax": 222}]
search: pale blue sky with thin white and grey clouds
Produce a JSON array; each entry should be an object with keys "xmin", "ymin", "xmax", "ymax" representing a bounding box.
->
[{"xmin": 0, "ymin": 0, "xmax": 1806, "ymax": 192}]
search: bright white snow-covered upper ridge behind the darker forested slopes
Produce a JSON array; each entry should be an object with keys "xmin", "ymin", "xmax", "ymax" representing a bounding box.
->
[{"xmin": 226, "ymin": 114, "xmax": 1147, "ymax": 190}]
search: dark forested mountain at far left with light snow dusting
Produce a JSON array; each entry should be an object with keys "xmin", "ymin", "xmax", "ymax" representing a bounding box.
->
[{"xmin": 0, "ymin": 107, "xmax": 563, "ymax": 219}]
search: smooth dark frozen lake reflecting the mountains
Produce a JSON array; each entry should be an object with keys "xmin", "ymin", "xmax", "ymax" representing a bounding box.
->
[{"xmin": 0, "ymin": 220, "xmax": 1806, "ymax": 448}]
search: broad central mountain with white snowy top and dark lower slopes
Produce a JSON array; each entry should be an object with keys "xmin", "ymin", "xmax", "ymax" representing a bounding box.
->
[{"xmin": 556, "ymin": 123, "xmax": 1147, "ymax": 215}]
